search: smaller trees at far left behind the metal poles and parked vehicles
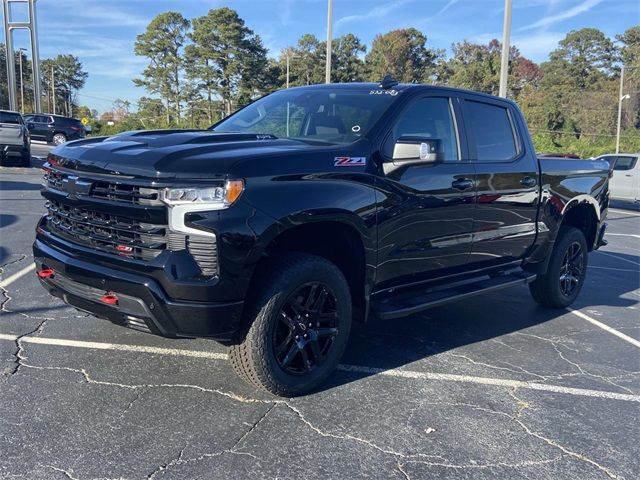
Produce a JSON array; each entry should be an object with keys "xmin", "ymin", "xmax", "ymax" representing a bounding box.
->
[{"xmin": 0, "ymin": 43, "xmax": 89, "ymax": 116}]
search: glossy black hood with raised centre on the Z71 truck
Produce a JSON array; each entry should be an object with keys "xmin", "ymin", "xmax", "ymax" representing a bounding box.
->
[{"xmin": 49, "ymin": 130, "xmax": 323, "ymax": 180}]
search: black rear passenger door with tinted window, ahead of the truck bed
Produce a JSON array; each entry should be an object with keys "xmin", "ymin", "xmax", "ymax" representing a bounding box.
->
[{"xmin": 462, "ymin": 96, "xmax": 540, "ymax": 269}]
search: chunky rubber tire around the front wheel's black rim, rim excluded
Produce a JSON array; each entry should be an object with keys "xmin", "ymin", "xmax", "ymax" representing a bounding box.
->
[{"xmin": 229, "ymin": 253, "xmax": 352, "ymax": 397}]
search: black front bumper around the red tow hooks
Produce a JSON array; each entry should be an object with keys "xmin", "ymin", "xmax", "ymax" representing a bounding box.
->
[{"xmin": 33, "ymin": 238, "xmax": 244, "ymax": 342}]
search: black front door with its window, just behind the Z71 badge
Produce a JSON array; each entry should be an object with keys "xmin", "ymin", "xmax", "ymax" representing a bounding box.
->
[{"xmin": 376, "ymin": 96, "xmax": 475, "ymax": 289}]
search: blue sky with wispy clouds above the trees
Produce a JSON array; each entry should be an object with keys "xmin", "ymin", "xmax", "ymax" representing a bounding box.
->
[{"xmin": 2, "ymin": 0, "xmax": 640, "ymax": 112}]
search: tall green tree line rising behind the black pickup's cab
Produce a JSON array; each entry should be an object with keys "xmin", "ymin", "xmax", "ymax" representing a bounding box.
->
[{"xmin": 129, "ymin": 7, "xmax": 640, "ymax": 155}]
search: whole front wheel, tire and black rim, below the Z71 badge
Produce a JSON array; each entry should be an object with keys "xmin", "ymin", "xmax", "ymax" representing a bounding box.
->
[{"xmin": 230, "ymin": 253, "xmax": 351, "ymax": 397}]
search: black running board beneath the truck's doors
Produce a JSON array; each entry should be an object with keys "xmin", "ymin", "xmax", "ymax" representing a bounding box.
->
[{"xmin": 371, "ymin": 270, "xmax": 536, "ymax": 320}]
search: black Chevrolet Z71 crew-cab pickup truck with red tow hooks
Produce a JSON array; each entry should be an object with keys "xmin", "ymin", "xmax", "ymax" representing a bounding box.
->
[{"xmin": 33, "ymin": 79, "xmax": 609, "ymax": 396}]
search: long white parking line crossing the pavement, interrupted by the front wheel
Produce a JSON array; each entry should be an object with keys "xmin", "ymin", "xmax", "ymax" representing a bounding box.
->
[{"xmin": 0, "ymin": 333, "xmax": 640, "ymax": 403}]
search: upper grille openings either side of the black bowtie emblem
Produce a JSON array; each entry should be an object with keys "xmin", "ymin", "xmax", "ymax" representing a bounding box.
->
[{"xmin": 44, "ymin": 170, "xmax": 162, "ymax": 205}]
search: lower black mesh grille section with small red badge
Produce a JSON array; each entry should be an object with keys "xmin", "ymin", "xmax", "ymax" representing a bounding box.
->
[{"xmin": 46, "ymin": 201, "xmax": 168, "ymax": 260}]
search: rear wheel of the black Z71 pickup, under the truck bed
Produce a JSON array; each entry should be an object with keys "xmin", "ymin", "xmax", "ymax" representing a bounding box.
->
[{"xmin": 529, "ymin": 227, "xmax": 587, "ymax": 308}]
